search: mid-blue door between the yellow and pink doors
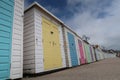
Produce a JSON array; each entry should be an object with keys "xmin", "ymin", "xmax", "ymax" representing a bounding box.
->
[{"xmin": 68, "ymin": 32, "xmax": 78, "ymax": 66}]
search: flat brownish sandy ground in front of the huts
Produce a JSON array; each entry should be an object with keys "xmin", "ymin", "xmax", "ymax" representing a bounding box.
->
[{"xmin": 22, "ymin": 58, "xmax": 120, "ymax": 80}]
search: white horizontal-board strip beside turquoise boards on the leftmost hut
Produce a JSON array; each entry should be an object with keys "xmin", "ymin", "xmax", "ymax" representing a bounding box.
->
[{"xmin": 10, "ymin": 0, "xmax": 24, "ymax": 79}]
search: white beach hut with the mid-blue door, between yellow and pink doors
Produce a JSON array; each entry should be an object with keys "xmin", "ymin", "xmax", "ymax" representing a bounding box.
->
[{"xmin": 63, "ymin": 26, "xmax": 80, "ymax": 67}]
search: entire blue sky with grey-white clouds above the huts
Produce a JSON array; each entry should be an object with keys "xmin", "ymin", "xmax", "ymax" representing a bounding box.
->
[{"xmin": 25, "ymin": 0, "xmax": 120, "ymax": 50}]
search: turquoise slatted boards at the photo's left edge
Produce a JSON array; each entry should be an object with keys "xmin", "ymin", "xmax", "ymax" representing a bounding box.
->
[{"xmin": 0, "ymin": 0, "xmax": 14, "ymax": 80}]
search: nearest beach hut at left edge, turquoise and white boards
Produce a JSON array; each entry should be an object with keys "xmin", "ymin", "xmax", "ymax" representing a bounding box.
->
[{"xmin": 0, "ymin": 0, "xmax": 24, "ymax": 80}]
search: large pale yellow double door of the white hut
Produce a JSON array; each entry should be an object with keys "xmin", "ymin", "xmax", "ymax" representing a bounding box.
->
[{"xmin": 42, "ymin": 18, "xmax": 62, "ymax": 70}]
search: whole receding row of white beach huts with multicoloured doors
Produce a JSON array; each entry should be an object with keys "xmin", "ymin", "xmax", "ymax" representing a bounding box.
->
[{"xmin": 0, "ymin": 0, "xmax": 115, "ymax": 80}]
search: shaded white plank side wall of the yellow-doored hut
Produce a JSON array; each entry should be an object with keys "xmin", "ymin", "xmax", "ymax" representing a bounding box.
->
[{"xmin": 23, "ymin": 9, "xmax": 36, "ymax": 73}]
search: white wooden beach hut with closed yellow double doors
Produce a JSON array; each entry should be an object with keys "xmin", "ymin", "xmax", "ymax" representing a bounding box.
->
[{"xmin": 24, "ymin": 2, "xmax": 66, "ymax": 74}]
